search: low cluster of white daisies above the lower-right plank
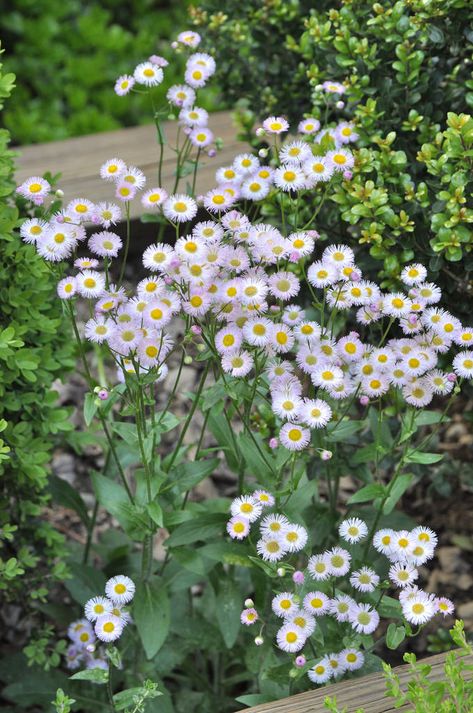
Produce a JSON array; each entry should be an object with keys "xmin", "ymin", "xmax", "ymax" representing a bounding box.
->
[{"xmin": 227, "ymin": 490, "xmax": 453, "ymax": 683}]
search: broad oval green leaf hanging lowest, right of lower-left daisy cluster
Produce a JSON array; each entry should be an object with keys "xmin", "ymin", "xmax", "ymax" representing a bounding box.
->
[{"xmin": 133, "ymin": 581, "xmax": 171, "ymax": 659}]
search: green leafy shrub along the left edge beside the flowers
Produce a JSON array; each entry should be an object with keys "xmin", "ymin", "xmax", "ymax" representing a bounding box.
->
[{"xmin": 0, "ymin": 48, "xmax": 74, "ymax": 665}]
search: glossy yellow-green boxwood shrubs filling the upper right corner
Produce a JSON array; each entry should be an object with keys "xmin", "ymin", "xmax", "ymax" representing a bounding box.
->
[{"xmin": 192, "ymin": 0, "xmax": 473, "ymax": 301}]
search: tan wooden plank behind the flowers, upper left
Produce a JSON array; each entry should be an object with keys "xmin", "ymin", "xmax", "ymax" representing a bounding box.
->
[{"xmin": 15, "ymin": 112, "xmax": 248, "ymax": 218}]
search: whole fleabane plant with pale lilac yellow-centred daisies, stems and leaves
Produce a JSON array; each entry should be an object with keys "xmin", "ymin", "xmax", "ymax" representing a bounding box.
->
[{"xmin": 13, "ymin": 32, "xmax": 473, "ymax": 705}]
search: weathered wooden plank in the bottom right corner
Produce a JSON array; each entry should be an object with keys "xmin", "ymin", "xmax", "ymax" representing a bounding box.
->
[{"xmin": 242, "ymin": 653, "xmax": 473, "ymax": 713}]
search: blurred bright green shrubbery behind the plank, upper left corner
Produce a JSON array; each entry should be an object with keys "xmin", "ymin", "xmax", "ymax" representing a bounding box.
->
[{"xmin": 2, "ymin": 0, "xmax": 219, "ymax": 144}]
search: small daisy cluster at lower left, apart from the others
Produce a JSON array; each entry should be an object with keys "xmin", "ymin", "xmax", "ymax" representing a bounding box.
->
[{"xmin": 66, "ymin": 575, "xmax": 135, "ymax": 669}]
